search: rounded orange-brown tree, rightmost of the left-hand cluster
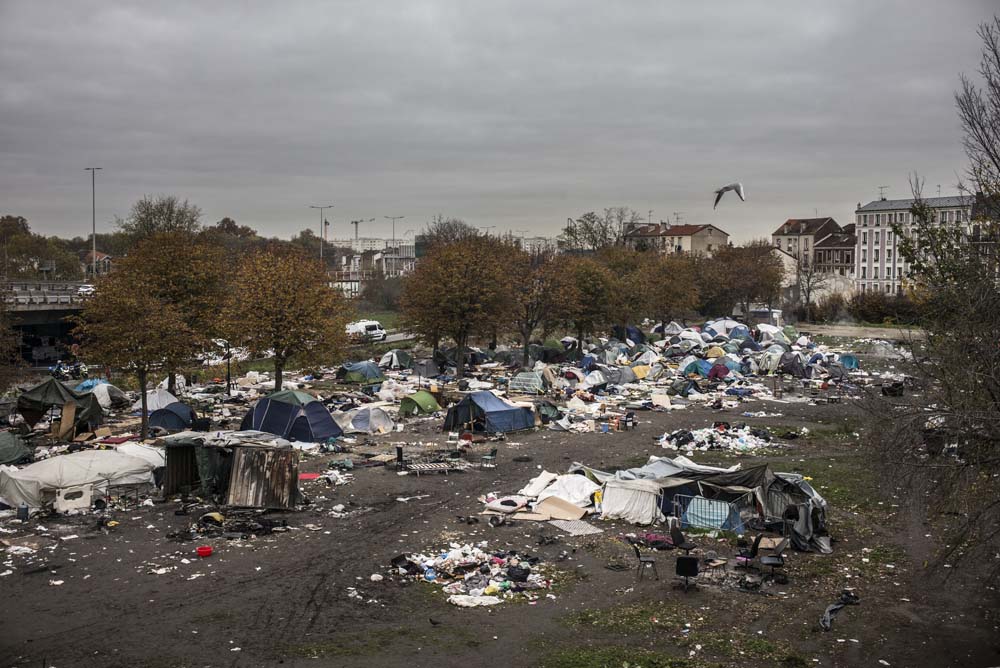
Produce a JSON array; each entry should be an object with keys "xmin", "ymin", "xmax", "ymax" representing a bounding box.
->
[{"xmin": 220, "ymin": 247, "xmax": 352, "ymax": 390}]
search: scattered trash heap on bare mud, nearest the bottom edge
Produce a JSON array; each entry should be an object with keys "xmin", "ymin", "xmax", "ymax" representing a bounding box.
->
[{"xmin": 392, "ymin": 542, "xmax": 554, "ymax": 608}]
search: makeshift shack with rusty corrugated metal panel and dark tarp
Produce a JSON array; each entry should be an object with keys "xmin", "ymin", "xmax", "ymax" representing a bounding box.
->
[{"xmin": 163, "ymin": 432, "xmax": 299, "ymax": 510}]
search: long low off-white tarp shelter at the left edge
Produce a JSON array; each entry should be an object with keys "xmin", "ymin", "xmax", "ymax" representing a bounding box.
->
[{"xmin": 0, "ymin": 450, "xmax": 154, "ymax": 508}]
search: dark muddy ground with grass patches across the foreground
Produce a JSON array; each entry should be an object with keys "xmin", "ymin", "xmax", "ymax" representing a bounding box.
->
[{"xmin": 0, "ymin": 394, "xmax": 1000, "ymax": 668}]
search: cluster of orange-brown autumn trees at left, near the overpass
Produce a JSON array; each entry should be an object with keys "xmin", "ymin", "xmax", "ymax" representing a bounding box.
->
[{"xmin": 75, "ymin": 198, "xmax": 352, "ymax": 431}]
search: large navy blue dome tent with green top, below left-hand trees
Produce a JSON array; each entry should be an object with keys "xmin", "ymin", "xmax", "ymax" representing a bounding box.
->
[{"xmin": 240, "ymin": 390, "xmax": 344, "ymax": 443}]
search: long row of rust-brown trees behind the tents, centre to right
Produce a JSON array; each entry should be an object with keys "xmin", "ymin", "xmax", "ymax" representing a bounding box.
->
[{"xmin": 400, "ymin": 235, "xmax": 783, "ymax": 363}]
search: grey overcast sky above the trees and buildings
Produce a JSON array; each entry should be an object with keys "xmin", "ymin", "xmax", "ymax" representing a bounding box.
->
[{"xmin": 0, "ymin": 0, "xmax": 995, "ymax": 240}]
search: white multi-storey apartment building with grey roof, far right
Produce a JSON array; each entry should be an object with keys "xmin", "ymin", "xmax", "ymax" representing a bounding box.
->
[{"xmin": 854, "ymin": 196, "xmax": 976, "ymax": 294}]
